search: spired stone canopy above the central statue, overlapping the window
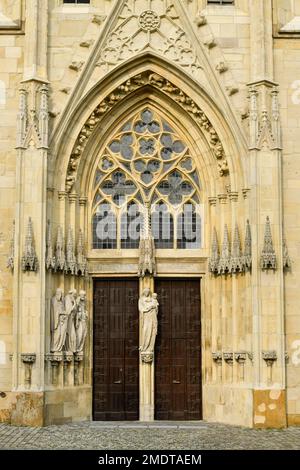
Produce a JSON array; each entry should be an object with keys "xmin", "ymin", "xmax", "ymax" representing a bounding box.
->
[{"xmin": 138, "ymin": 205, "xmax": 156, "ymax": 277}]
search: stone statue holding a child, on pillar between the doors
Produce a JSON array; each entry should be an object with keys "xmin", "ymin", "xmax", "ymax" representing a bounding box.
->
[{"xmin": 139, "ymin": 288, "xmax": 159, "ymax": 362}]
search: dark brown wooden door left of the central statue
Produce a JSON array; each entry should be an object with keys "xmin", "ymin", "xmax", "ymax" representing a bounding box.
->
[{"xmin": 93, "ymin": 279, "xmax": 139, "ymax": 421}]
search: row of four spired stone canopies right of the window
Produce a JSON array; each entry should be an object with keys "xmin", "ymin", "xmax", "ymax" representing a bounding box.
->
[{"xmin": 208, "ymin": 220, "xmax": 252, "ymax": 275}]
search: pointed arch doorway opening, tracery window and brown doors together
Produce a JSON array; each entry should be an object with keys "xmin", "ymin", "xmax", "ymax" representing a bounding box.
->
[{"xmin": 90, "ymin": 105, "xmax": 202, "ymax": 420}]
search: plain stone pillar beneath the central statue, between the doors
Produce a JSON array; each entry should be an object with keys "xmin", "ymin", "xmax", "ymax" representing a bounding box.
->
[{"xmin": 140, "ymin": 355, "xmax": 154, "ymax": 421}]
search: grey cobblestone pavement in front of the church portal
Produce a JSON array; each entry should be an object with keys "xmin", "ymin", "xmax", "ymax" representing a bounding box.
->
[{"xmin": 0, "ymin": 421, "xmax": 300, "ymax": 450}]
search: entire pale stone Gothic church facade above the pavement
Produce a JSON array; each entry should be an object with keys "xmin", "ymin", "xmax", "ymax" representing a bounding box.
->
[{"xmin": 0, "ymin": 0, "xmax": 300, "ymax": 427}]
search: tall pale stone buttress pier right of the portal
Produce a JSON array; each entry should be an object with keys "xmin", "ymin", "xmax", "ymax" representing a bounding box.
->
[{"xmin": 249, "ymin": 0, "xmax": 286, "ymax": 427}]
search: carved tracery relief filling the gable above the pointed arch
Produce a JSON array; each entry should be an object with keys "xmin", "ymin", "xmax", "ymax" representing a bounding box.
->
[{"xmin": 97, "ymin": 0, "xmax": 201, "ymax": 74}]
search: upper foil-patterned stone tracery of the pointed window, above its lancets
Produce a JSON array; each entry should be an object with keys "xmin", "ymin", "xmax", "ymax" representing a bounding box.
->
[{"xmin": 94, "ymin": 107, "xmax": 199, "ymax": 209}]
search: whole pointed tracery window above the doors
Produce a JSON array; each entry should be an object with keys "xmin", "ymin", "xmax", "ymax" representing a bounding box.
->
[{"xmin": 92, "ymin": 107, "xmax": 201, "ymax": 249}]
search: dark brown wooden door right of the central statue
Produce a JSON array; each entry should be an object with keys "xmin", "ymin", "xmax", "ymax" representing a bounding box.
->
[{"xmin": 155, "ymin": 279, "xmax": 202, "ymax": 420}]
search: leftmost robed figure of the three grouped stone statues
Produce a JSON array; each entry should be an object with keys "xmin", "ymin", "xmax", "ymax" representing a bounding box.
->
[{"xmin": 50, "ymin": 289, "xmax": 68, "ymax": 352}]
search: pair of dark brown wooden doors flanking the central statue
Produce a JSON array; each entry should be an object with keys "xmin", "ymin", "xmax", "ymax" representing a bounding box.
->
[{"xmin": 93, "ymin": 279, "xmax": 202, "ymax": 421}]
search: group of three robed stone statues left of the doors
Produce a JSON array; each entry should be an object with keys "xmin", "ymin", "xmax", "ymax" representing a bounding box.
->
[{"xmin": 50, "ymin": 288, "xmax": 88, "ymax": 355}]
